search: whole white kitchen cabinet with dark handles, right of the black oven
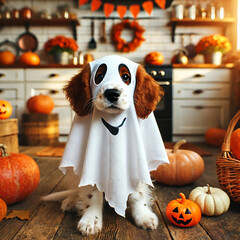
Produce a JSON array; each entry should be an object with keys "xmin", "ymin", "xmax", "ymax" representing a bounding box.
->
[{"xmin": 173, "ymin": 68, "xmax": 231, "ymax": 141}]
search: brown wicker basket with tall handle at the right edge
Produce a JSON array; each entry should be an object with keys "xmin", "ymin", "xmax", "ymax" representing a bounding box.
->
[{"xmin": 216, "ymin": 111, "xmax": 240, "ymax": 202}]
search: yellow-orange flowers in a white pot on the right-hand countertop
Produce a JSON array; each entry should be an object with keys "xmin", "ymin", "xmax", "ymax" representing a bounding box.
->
[{"xmin": 196, "ymin": 34, "xmax": 232, "ymax": 65}]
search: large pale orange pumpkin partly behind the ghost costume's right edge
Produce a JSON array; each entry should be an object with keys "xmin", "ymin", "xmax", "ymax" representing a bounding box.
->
[{"xmin": 151, "ymin": 139, "xmax": 204, "ymax": 186}]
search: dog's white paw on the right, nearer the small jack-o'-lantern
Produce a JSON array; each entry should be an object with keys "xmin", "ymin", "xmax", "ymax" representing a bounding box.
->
[{"xmin": 133, "ymin": 207, "xmax": 158, "ymax": 230}]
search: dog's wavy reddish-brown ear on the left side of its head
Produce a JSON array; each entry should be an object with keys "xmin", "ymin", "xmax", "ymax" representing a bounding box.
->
[{"xmin": 63, "ymin": 64, "xmax": 92, "ymax": 116}]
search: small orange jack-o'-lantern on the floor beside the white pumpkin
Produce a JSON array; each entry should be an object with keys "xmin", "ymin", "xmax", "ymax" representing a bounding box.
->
[{"xmin": 166, "ymin": 193, "xmax": 202, "ymax": 227}]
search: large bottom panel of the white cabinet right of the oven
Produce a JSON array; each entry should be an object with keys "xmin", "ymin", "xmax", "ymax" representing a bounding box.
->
[{"xmin": 173, "ymin": 100, "xmax": 229, "ymax": 135}]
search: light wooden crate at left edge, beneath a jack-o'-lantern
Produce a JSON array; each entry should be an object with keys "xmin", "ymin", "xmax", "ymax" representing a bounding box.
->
[{"xmin": 0, "ymin": 118, "xmax": 19, "ymax": 153}]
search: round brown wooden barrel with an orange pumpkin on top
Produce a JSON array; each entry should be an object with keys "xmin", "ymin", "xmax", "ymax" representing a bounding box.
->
[{"xmin": 22, "ymin": 113, "xmax": 59, "ymax": 146}]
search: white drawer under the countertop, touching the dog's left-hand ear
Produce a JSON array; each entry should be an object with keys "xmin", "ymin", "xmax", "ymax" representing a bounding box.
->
[{"xmin": 26, "ymin": 68, "xmax": 80, "ymax": 82}]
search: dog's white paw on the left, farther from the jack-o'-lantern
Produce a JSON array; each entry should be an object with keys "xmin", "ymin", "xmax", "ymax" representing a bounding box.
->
[{"xmin": 77, "ymin": 214, "xmax": 102, "ymax": 235}]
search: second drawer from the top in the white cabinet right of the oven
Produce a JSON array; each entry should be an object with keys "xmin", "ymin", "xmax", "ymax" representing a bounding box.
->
[{"xmin": 173, "ymin": 83, "xmax": 230, "ymax": 99}]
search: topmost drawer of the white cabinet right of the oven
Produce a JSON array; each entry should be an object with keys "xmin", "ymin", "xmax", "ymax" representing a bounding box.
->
[{"xmin": 173, "ymin": 68, "xmax": 231, "ymax": 82}]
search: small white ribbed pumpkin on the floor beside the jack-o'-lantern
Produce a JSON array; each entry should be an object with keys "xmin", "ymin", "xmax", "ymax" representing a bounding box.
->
[{"xmin": 189, "ymin": 184, "xmax": 230, "ymax": 216}]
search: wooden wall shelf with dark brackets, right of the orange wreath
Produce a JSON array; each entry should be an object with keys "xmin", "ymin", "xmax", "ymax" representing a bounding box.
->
[{"xmin": 170, "ymin": 18, "xmax": 235, "ymax": 42}]
